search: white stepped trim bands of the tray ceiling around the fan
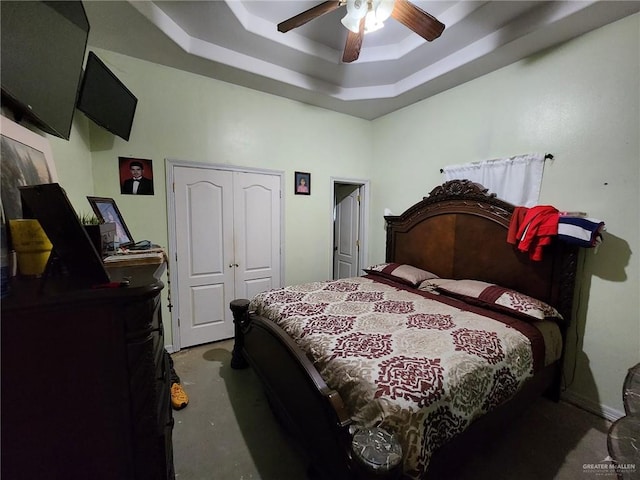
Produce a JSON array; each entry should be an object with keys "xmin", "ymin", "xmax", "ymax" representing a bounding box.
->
[{"xmin": 124, "ymin": 0, "xmax": 636, "ymax": 101}]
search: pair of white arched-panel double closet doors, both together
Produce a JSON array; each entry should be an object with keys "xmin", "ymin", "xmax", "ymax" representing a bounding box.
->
[{"xmin": 170, "ymin": 166, "xmax": 281, "ymax": 348}]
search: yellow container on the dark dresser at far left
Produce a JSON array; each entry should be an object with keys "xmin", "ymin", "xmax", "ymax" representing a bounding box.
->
[{"xmin": 9, "ymin": 219, "xmax": 53, "ymax": 275}]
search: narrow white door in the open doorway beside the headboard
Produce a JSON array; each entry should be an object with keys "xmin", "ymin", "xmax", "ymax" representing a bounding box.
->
[{"xmin": 333, "ymin": 184, "xmax": 360, "ymax": 279}]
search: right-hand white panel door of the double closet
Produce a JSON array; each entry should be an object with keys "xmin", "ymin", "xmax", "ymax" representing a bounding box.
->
[{"xmin": 233, "ymin": 172, "xmax": 281, "ymax": 299}]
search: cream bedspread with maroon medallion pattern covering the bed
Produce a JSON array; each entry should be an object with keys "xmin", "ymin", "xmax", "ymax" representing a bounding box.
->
[{"xmin": 250, "ymin": 277, "xmax": 556, "ymax": 478}]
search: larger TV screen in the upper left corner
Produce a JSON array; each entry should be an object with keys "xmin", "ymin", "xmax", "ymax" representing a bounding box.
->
[{"xmin": 0, "ymin": 0, "xmax": 89, "ymax": 140}]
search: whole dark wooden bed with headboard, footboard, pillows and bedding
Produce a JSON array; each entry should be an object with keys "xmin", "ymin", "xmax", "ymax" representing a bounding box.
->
[{"xmin": 231, "ymin": 180, "xmax": 577, "ymax": 479}]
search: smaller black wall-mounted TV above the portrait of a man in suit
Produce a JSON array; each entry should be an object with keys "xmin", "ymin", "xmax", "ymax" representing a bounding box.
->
[{"xmin": 78, "ymin": 52, "xmax": 138, "ymax": 140}]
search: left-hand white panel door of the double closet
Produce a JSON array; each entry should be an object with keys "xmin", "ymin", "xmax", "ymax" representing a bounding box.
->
[{"xmin": 171, "ymin": 167, "xmax": 235, "ymax": 348}]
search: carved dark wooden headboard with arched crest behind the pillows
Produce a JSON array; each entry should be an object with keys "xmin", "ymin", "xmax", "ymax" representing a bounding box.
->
[{"xmin": 385, "ymin": 180, "xmax": 577, "ymax": 319}]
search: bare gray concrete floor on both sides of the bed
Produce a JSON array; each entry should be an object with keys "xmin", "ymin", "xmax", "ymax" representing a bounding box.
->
[{"xmin": 172, "ymin": 341, "xmax": 616, "ymax": 480}]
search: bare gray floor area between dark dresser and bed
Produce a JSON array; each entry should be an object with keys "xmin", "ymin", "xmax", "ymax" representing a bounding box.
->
[{"xmin": 172, "ymin": 341, "xmax": 306, "ymax": 480}]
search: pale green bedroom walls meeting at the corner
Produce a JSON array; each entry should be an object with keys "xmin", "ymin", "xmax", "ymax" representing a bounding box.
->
[{"xmin": 42, "ymin": 15, "xmax": 640, "ymax": 418}]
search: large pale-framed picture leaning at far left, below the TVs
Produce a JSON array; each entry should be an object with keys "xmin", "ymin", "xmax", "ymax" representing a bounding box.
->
[{"xmin": 0, "ymin": 116, "xmax": 58, "ymax": 220}]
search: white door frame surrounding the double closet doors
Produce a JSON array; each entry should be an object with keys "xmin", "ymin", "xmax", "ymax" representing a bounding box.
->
[{"xmin": 165, "ymin": 158, "xmax": 285, "ymax": 353}]
